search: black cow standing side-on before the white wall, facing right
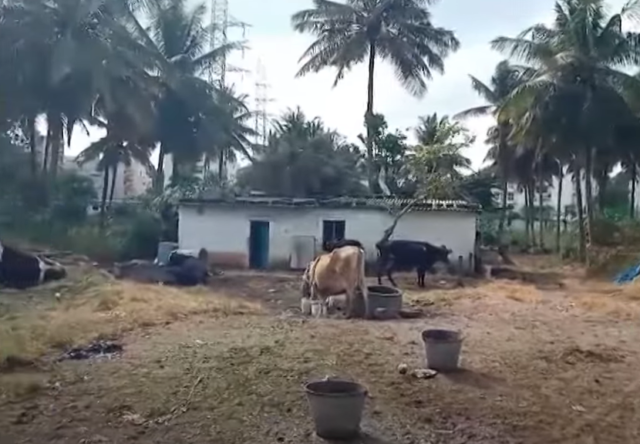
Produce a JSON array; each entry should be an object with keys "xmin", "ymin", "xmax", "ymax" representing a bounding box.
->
[{"xmin": 376, "ymin": 240, "xmax": 451, "ymax": 287}]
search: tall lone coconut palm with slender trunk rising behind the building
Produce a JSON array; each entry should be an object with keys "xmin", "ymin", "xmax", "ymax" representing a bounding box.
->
[{"xmin": 291, "ymin": 0, "xmax": 460, "ymax": 190}]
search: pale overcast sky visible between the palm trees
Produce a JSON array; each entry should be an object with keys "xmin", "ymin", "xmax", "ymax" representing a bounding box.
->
[{"xmin": 70, "ymin": 0, "xmax": 624, "ymax": 167}]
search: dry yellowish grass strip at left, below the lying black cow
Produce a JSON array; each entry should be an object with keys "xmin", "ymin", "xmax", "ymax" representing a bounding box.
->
[{"xmin": 0, "ymin": 272, "xmax": 261, "ymax": 367}]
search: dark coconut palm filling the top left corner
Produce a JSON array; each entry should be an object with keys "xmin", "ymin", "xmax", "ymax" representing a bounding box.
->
[{"xmin": 0, "ymin": 0, "xmax": 155, "ymax": 177}]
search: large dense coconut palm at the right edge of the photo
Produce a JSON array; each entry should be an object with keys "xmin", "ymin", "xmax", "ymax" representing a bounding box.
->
[{"xmin": 492, "ymin": 0, "xmax": 640, "ymax": 258}]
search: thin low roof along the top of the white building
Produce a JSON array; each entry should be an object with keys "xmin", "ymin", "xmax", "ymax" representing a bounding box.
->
[{"xmin": 180, "ymin": 196, "xmax": 481, "ymax": 212}]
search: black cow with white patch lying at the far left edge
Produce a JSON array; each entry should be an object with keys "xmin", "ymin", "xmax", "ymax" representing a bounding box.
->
[{"xmin": 0, "ymin": 243, "xmax": 67, "ymax": 290}]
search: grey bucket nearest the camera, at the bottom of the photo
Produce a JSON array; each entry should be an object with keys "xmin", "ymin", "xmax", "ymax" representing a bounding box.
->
[{"xmin": 304, "ymin": 379, "xmax": 367, "ymax": 440}]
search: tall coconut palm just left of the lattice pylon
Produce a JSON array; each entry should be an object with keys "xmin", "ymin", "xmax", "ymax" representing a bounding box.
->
[{"xmin": 121, "ymin": 0, "xmax": 246, "ymax": 188}]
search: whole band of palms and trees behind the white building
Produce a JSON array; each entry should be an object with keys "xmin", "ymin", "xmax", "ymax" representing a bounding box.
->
[{"xmin": 0, "ymin": 0, "xmax": 640, "ymax": 259}]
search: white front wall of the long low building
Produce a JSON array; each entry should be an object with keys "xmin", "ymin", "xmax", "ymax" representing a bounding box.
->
[{"xmin": 178, "ymin": 204, "xmax": 476, "ymax": 267}]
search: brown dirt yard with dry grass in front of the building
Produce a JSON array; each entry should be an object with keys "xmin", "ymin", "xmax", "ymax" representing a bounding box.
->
[{"xmin": 0, "ymin": 258, "xmax": 640, "ymax": 444}]
